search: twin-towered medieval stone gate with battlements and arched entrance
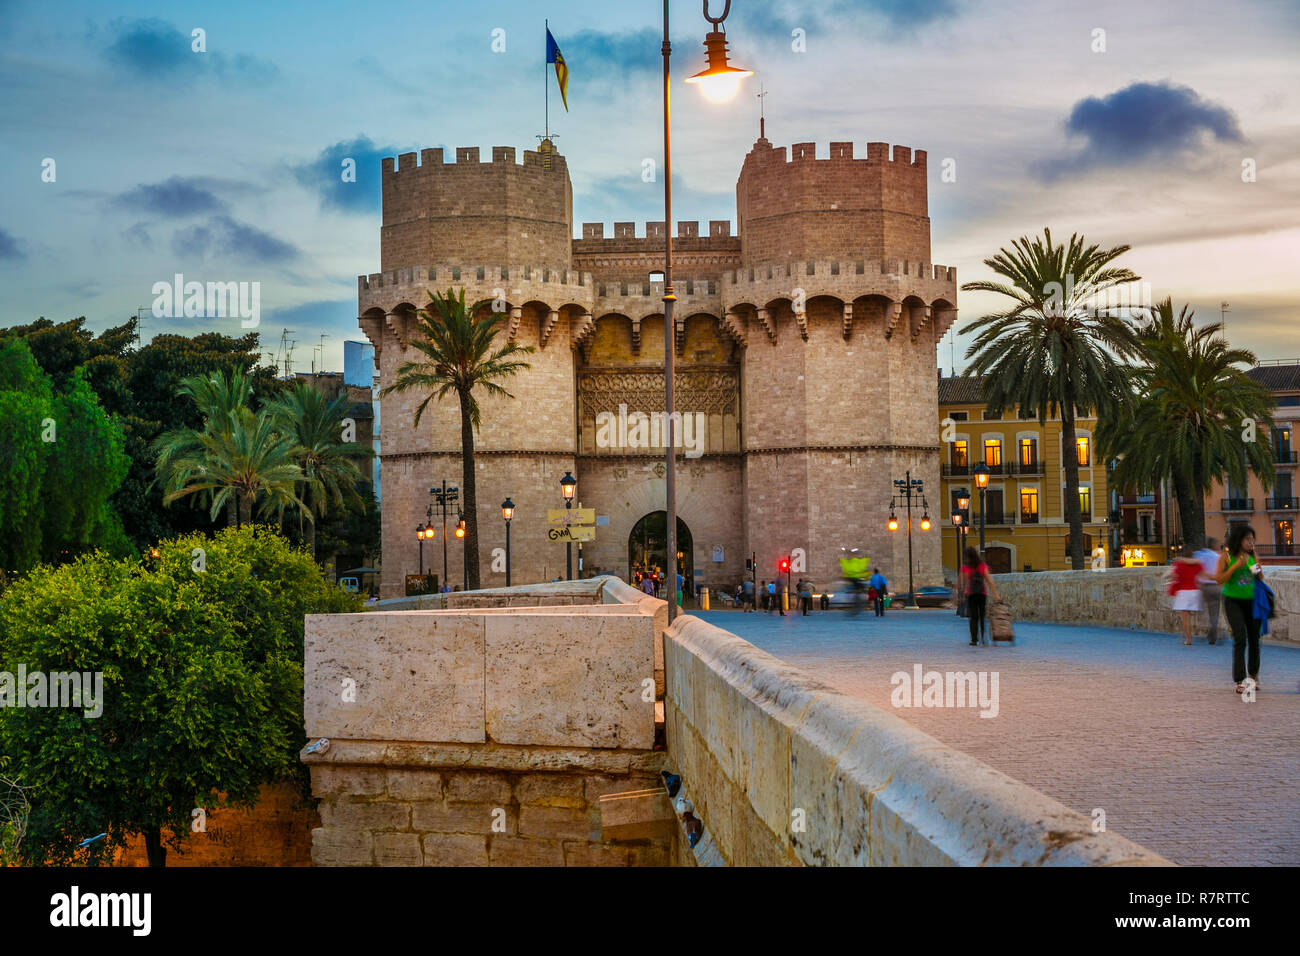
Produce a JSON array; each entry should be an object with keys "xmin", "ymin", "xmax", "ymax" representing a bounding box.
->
[{"xmin": 358, "ymin": 139, "xmax": 957, "ymax": 597}]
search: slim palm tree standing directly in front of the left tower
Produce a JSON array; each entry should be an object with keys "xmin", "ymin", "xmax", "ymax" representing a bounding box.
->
[{"xmin": 380, "ymin": 289, "xmax": 533, "ymax": 591}]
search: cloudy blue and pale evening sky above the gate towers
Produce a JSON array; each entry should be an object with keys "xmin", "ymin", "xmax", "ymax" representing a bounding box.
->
[{"xmin": 0, "ymin": 0, "xmax": 1300, "ymax": 369}]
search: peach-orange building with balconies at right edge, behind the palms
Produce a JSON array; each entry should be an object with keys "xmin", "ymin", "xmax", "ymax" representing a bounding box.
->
[{"xmin": 1205, "ymin": 360, "xmax": 1300, "ymax": 564}]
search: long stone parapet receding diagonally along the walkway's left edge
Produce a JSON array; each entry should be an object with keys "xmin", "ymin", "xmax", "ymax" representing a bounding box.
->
[{"xmin": 666, "ymin": 617, "xmax": 1167, "ymax": 866}]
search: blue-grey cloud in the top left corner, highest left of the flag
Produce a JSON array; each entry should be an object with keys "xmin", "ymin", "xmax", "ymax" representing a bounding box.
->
[{"xmin": 104, "ymin": 17, "xmax": 278, "ymax": 83}]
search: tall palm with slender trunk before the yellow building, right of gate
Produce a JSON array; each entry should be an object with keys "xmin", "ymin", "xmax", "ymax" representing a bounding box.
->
[{"xmin": 962, "ymin": 229, "xmax": 1139, "ymax": 571}]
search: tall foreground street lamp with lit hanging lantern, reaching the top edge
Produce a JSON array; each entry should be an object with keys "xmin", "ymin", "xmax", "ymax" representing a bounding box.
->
[{"xmin": 660, "ymin": 0, "xmax": 750, "ymax": 624}]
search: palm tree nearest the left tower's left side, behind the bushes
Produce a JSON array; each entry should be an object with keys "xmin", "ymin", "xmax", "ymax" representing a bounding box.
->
[{"xmin": 272, "ymin": 382, "xmax": 374, "ymax": 557}]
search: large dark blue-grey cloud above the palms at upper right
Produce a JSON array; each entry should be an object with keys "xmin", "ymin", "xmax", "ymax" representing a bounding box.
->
[{"xmin": 1034, "ymin": 81, "xmax": 1244, "ymax": 181}]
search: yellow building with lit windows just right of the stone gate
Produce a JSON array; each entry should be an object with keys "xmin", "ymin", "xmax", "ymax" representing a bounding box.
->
[{"xmin": 939, "ymin": 376, "xmax": 1128, "ymax": 574}]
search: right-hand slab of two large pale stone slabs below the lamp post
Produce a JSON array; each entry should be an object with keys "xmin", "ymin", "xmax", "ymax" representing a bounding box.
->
[{"xmin": 484, "ymin": 614, "xmax": 654, "ymax": 749}]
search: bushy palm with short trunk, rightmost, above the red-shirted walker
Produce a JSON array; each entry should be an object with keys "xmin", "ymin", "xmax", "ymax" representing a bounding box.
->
[{"xmin": 1097, "ymin": 298, "xmax": 1274, "ymax": 548}]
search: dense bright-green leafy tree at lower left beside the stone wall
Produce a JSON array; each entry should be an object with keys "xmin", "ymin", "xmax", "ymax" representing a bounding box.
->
[{"xmin": 0, "ymin": 527, "xmax": 360, "ymax": 866}]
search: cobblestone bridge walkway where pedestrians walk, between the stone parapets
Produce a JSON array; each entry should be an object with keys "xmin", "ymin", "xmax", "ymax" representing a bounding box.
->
[{"xmin": 699, "ymin": 609, "xmax": 1300, "ymax": 866}]
